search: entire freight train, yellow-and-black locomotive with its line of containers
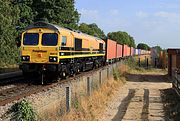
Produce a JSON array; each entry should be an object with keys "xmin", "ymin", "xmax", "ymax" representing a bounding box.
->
[{"xmin": 17, "ymin": 22, "xmax": 150, "ymax": 84}]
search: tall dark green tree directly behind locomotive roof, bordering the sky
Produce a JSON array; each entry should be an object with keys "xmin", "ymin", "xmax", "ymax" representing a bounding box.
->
[{"xmin": 32, "ymin": 0, "xmax": 80, "ymax": 29}]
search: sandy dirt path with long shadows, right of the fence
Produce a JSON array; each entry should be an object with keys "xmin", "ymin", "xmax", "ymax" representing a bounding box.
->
[{"xmin": 98, "ymin": 71, "xmax": 171, "ymax": 121}]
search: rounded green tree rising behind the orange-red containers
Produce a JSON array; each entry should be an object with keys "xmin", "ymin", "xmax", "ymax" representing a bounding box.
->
[{"xmin": 107, "ymin": 31, "xmax": 136, "ymax": 47}]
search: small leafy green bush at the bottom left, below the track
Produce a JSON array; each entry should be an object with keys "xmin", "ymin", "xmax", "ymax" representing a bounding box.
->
[{"xmin": 11, "ymin": 100, "xmax": 37, "ymax": 121}]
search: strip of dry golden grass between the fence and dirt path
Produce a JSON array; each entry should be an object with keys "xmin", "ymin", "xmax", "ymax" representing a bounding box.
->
[{"xmin": 61, "ymin": 65, "xmax": 126, "ymax": 121}]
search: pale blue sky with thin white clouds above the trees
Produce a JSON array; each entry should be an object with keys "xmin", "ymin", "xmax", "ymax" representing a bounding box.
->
[{"xmin": 76, "ymin": 0, "xmax": 180, "ymax": 48}]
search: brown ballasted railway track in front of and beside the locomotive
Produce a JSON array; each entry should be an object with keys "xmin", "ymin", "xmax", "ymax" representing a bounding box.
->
[{"xmin": 0, "ymin": 66, "xmax": 107, "ymax": 106}]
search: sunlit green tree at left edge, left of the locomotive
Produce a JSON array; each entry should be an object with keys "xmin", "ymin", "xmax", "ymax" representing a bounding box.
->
[{"xmin": 0, "ymin": 0, "xmax": 19, "ymax": 67}]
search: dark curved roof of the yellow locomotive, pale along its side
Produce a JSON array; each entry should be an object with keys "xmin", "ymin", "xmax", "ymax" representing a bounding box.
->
[{"xmin": 25, "ymin": 21, "xmax": 102, "ymax": 40}]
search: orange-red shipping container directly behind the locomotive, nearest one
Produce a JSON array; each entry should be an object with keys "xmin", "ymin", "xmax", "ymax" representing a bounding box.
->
[{"xmin": 106, "ymin": 39, "xmax": 117, "ymax": 62}]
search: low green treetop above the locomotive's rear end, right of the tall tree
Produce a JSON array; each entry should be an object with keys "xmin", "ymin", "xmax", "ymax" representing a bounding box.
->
[{"xmin": 79, "ymin": 23, "xmax": 106, "ymax": 39}]
